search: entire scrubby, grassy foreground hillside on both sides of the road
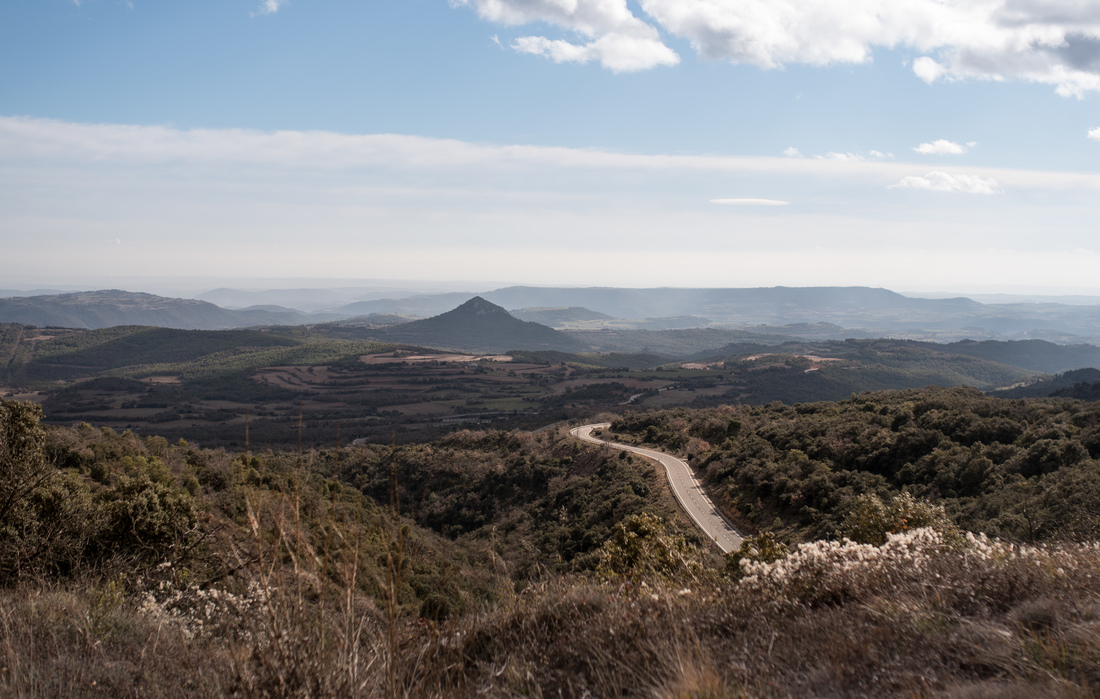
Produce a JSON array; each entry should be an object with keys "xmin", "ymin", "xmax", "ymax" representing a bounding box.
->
[{"xmin": 0, "ymin": 390, "xmax": 1100, "ymax": 698}]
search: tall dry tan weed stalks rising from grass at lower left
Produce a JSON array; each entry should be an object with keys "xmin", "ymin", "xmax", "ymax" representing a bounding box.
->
[{"xmin": 221, "ymin": 407, "xmax": 380, "ymax": 697}]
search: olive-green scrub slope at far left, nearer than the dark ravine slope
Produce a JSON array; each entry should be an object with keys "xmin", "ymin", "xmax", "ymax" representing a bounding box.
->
[{"xmin": 0, "ymin": 402, "xmax": 496, "ymax": 618}]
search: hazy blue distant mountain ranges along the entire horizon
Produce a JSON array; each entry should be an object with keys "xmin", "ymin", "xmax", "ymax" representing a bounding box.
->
[{"xmin": 0, "ymin": 286, "xmax": 1100, "ymax": 347}]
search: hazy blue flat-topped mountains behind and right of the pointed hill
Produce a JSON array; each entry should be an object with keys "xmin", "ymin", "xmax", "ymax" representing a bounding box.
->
[{"xmin": 332, "ymin": 286, "xmax": 1100, "ymax": 343}]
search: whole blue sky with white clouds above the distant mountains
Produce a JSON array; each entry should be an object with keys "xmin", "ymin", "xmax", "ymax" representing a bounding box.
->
[{"xmin": 0, "ymin": 0, "xmax": 1100, "ymax": 294}]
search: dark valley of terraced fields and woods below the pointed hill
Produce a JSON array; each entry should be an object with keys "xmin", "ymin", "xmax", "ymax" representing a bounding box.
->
[{"xmin": 0, "ymin": 325, "xmax": 1064, "ymax": 448}]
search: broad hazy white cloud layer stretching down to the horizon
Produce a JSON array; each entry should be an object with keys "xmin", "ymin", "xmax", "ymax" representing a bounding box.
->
[{"xmin": 0, "ymin": 117, "xmax": 1100, "ymax": 286}]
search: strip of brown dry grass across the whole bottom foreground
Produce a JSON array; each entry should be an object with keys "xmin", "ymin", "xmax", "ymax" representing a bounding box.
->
[{"xmin": 0, "ymin": 528, "xmax": 1100, "ymax": 699}]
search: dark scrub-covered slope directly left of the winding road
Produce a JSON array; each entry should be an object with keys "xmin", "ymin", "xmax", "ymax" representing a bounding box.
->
[{"xmin": 342, "ymin": 430, "xmax": 699, "ymax": 578}]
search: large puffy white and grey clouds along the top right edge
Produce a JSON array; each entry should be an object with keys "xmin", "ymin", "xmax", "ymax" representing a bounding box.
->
[{"xmin": 452, "ymin": 0, "xmax": 1100, "ymax": 97}]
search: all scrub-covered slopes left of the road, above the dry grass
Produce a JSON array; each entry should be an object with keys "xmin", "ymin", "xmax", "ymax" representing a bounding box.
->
[{"xmin": 0, "ymin": 405, "xmax": 699, "ymax": 618}]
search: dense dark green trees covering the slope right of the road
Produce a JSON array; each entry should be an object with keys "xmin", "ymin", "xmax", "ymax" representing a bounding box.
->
[{"xmin": 613, "ymin": 389, "xmax": 1100, "ymax": 540}]
